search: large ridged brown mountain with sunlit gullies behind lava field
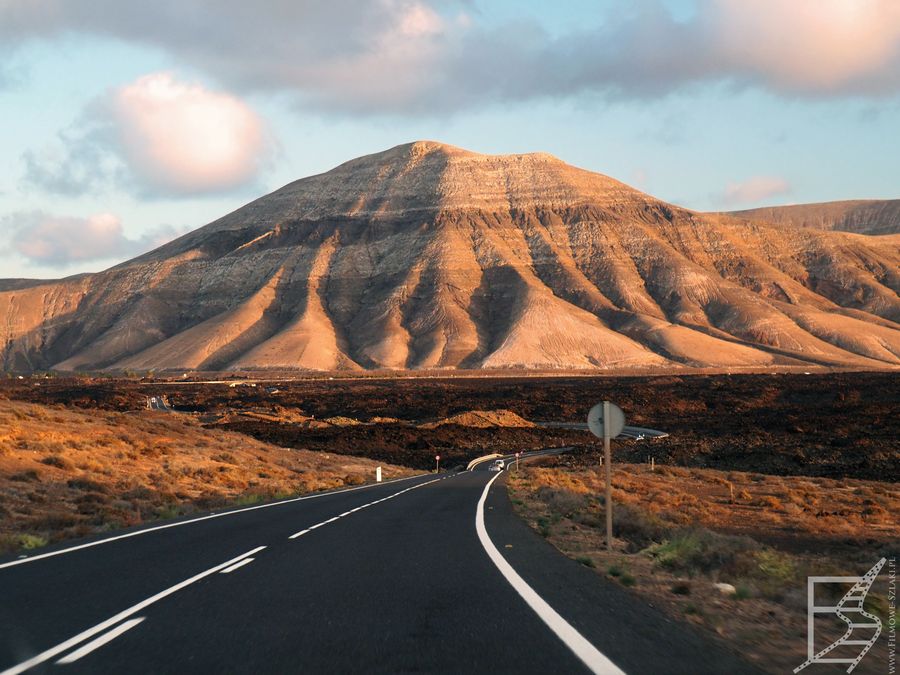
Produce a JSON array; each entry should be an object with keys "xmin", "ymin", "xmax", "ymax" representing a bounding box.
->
[{"xmin": 0, "ymin": 141, "xmax": 900, "ymax": 370}]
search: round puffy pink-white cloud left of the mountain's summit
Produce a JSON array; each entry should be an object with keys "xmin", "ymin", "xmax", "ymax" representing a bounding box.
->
[{"xmin": 23, "ymin": 73, "xmax": 271, "ymax": 196}]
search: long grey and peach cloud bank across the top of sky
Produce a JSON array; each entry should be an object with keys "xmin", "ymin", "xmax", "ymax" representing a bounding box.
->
[{"xmin": 0, "ymin": 0, "xmax": 900, "ymax": 115}]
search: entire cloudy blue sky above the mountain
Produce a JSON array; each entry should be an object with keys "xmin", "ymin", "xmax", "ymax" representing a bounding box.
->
[{"xmin": 0, "ymin": 0, "xmax": 900, "ymax": 277}]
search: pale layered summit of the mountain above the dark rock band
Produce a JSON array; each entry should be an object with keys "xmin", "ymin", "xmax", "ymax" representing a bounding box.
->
[{"xmin": 199, "ymin": 140, "xmax": 640, "ymax": 236}]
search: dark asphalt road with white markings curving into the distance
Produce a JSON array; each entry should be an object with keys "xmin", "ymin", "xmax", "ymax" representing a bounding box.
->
[{"xmin": 0, "ymin": 452, "xmax": 756, "ymax": 674}]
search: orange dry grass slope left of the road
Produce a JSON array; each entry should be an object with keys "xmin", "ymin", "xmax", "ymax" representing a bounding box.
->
[{"xmin": 0, "ymin": 400, "xmax": 412, "ymax": 553}]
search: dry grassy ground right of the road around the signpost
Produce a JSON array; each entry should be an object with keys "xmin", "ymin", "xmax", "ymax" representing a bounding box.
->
[{"xmin": 508, "ymin": 459, "xmax": 900, "ymax": 673}]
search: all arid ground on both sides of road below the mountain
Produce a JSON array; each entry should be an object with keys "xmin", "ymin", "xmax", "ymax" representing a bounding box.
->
[{"xmin": 0, "ymin": 372, "xmax": 900, "ymax": 673}]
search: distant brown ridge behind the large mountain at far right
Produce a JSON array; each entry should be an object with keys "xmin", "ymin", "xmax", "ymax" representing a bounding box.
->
[{"xmin": 731, "ymin": 199, "xmax": 900, "ymax": 234}]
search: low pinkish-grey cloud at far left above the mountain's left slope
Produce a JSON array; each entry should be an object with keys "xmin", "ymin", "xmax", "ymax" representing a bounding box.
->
[{"xmin": 0, "ymin": 211, "xmax": 185, "ymax": 267}]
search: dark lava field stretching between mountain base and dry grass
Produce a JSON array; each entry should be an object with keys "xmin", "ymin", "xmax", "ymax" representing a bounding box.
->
[{"xmin": 0, "ymin": 373, "xmax": 900, "ymax": 480}]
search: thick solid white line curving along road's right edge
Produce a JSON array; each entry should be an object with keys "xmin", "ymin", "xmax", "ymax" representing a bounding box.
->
[{"xmin": 475, "ymin": 473, "xmax": 625, "ymax": 675}]
